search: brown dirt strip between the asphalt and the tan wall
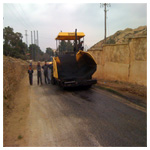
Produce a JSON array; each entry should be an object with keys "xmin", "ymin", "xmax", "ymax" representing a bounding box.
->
[{"xmin": 94, "ymin": 81, "xmax": 147, "ymax": 109}]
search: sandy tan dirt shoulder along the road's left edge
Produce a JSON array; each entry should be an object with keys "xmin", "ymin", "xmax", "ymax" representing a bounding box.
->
[{"xmin": 3, "ymin": 75, "xmax": 30, "ymax": 147}]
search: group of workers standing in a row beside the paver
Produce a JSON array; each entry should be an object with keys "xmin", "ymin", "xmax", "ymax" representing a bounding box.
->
[{"xmin": 28, "ymin": 61, "xmax": 52, "ymax": 85}]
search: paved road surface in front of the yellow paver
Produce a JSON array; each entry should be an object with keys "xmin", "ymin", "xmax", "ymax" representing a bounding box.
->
[{"xmin": 27, "ymin": 75, "xmax": 147, "ymax": 147}]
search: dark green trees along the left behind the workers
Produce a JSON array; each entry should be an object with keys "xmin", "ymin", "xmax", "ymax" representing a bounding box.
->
[{"xmin": 3, "ymin": 26, "xmax": 54, "ymax": 61}]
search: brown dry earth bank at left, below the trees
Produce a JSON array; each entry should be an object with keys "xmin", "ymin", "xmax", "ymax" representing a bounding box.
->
[{"xmin": 3, "ymin": 56, "xmax": 28, "ymax": 108}]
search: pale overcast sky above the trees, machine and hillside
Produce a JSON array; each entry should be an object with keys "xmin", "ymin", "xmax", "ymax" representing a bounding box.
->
[{"xmin": 3, "ymin": 3, "xmax": 147, "ymax": 51}]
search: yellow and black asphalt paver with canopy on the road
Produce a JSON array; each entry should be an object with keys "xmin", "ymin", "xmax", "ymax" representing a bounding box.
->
[{"xmin": 51, "ymin": 30, "xmax": 97, "ymax": 87}]
